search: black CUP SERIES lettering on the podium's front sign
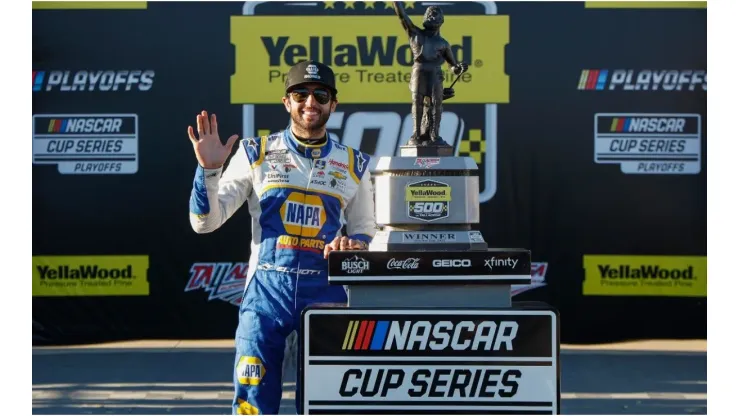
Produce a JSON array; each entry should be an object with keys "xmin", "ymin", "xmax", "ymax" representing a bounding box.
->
[{"xmin": 339, "ymin": 368, "xmax": 522, "ymax": 398}]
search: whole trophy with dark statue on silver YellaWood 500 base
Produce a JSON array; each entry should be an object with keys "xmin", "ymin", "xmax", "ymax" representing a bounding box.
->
[{"xmin": 370, "ymin": 2, "xmax": 487, "ymax": 251}]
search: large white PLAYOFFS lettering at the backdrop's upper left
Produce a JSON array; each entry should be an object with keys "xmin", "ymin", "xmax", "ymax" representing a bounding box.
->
[{"xmin": 46, "ymin": 70, "xmax": 154, "ymax": 91}]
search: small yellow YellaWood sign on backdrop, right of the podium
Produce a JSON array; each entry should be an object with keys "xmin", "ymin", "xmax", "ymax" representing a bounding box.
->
[{"xmin": 583, "ymin": 255, "xmax": 707, "ymax": 297}]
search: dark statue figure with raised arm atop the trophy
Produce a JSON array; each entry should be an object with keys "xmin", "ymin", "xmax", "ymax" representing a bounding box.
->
[{"xmin": 393, "ymin": 1, "xmax": 468, "ymax": 146}]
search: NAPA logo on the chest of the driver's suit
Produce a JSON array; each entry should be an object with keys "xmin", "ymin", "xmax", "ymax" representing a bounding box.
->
[{"xmin": 280, "ymin": 192, "xmax": 326, "ymax": 238}]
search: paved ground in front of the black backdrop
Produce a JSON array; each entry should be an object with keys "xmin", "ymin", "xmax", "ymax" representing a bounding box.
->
[{"xmin": 33, "ymin": 340, "xmax": 707, "ymax": 415}]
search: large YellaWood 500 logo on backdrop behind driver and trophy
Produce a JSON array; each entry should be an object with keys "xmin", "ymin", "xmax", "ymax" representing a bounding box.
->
[{"xmin": 231, "ymin": 2, "xmax": 509, "ymax": 203}]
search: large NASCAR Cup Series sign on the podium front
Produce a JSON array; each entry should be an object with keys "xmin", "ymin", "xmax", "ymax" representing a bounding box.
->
[{"xmin": 301, "ymin": 307, "xmax": 560, "ymax": 415}]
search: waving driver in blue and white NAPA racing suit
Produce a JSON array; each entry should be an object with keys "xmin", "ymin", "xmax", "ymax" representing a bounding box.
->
[{"xmin": 188, "ymin": 61, "xmax": 375, "ymax": 414}]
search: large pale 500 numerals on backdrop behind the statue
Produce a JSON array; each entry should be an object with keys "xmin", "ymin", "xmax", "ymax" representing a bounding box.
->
[{"xmin": 326, "ymin": 111, "xmax": 464, "ymax": 156}]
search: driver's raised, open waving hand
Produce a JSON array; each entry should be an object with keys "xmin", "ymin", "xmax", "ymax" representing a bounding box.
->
[{"xmin": 188, "ymin": 111, "xmax": 239, "ymax": 169}]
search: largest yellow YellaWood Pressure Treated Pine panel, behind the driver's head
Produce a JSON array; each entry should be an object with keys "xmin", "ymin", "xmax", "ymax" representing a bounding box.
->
[{"xmin": 231, "ymin": 15, "xmax": 509, "ymax": 104}]
